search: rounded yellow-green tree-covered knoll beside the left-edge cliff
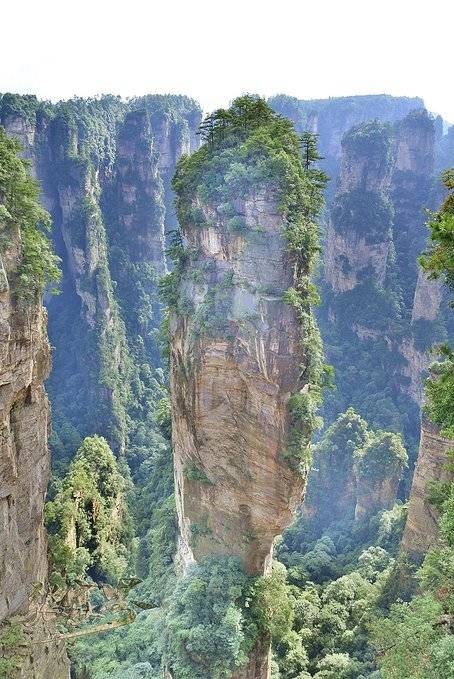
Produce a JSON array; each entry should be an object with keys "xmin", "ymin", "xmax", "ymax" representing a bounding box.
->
[{"xmin": 46, "ymin": 436, "xmax": 131, "ymax": 588}]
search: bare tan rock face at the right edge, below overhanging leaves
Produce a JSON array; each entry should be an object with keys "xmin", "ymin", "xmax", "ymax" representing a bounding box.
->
[{"xmin": 401, "ymin": 417, "xmax": 454, "ymax": 561}]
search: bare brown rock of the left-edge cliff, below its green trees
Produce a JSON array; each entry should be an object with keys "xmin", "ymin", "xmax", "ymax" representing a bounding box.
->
[{"xmin": 0, "ymin": 232, "xmax": 69, "ymax": 679}]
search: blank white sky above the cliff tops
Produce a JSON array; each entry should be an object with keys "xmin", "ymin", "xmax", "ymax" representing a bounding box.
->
[{"xmin": 0, "ymin": 0, "xmax": 454, "ymax": 122}]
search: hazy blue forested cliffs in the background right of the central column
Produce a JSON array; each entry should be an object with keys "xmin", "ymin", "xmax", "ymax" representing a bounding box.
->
[{"xmin": 272, "ymin": 97, "xmax": 453, "ymax": 467}]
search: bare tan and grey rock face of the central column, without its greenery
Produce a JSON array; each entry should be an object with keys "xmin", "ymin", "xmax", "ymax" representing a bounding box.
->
[{"xmin": 171, "ymin": 193, "xmax": 303, "ymax": 573}]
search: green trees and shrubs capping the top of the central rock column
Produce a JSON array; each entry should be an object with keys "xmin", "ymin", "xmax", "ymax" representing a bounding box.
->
[{"xmin": 173, "ymin": 96, "xmax": 323, "ymax": 284}]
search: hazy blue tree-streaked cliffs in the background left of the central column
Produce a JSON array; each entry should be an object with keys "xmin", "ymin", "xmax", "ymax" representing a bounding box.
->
[{"xmin": 0, "ymin": 95, "xmax": 200, "ymax": 464}]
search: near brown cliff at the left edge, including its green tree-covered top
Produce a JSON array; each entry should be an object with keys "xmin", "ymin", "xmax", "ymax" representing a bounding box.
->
[{"xmin": 0, "ymin": 129, "xmax": 68, "ymax": 679}]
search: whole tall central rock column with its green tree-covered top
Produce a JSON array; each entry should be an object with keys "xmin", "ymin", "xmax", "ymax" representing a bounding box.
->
[{"xmin": 166, "ymin": 98, "xmax": 321, "ymax": 679}]
